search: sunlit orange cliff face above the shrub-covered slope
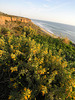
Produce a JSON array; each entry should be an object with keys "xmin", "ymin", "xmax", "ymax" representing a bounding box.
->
[{"xmin": 0, "ymin": 16, "xmax": 31, "ymax": 25}]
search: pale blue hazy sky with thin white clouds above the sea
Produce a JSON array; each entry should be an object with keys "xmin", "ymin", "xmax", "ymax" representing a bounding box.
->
[{"xmin": 0, "ymin": 0, "xmax": 75, "ymax": 25}]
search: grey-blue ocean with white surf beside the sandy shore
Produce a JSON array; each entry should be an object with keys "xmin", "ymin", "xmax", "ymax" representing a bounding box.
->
[{"xmin": 32, "ymin": 19, "xmax": 75, "ymax": 43}]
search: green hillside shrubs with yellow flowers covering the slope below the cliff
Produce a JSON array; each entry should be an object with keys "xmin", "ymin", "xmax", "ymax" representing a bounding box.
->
[{"xmin": 0, "ymin": 12, "xmax": 75, "ymax": 100}]
